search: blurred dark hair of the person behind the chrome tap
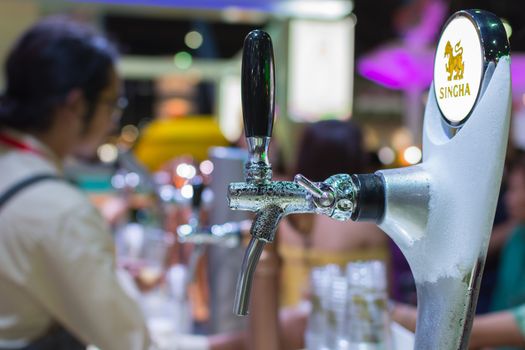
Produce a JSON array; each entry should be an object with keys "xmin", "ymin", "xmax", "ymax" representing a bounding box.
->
[{"xmin": 296, "ymin": 120, "xmax": 368, "ymax": 181}]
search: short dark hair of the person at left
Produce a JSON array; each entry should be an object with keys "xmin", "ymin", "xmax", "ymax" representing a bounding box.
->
[{"xmin": 0, "ymin": 17, "xmax": 117, "ymax": 131}]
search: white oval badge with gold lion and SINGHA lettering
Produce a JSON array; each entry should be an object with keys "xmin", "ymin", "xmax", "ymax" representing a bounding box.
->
[{"xmin": 434, "ymin": 16, "xmax": 484, "ymax": 125}]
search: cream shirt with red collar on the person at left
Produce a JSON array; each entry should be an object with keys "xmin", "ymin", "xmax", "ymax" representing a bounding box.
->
[{"xmin": 0, "ymin": 134, "xmax": 150, "ymax": 350}]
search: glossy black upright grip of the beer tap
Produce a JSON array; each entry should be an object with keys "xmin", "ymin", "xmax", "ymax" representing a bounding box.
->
[{"xmin": 241, "ymin": 29, "xmax": 275, "ymax": 137}]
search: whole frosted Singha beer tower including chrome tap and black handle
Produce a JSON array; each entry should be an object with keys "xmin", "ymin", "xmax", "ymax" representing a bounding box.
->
[{"xmin": 228, "ymin": 10, "xmax": 511, "ymax": 350}]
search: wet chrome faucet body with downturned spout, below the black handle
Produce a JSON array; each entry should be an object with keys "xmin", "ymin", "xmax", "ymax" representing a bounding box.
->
[{"xmin": 228, "ymin": 175, "xmax": 368, "ymax": 315}]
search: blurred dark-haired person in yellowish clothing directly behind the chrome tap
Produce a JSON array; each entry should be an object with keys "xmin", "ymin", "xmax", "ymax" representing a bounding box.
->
[{"xmin": 277, "ymin": 120, "xmax": 389, "ymax": 307}]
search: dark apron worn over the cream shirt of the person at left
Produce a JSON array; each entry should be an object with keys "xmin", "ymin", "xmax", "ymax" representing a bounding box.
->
[{"xmin": 0, "ymin": 174, "xmax": 86, "ymax": 350}]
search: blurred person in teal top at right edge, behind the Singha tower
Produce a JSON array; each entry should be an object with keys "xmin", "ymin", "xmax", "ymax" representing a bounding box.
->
[{"xmin": 392, "ymin": 154, "xmax": 525, "ymax": 350}]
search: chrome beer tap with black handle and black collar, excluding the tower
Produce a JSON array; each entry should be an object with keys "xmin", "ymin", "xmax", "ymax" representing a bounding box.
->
[{"xmin": 228, "ymin": 30, "xmax": 383, "ymax": 315}]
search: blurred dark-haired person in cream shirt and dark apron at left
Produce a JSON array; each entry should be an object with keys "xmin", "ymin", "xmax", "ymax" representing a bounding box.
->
[{"xmin": 0, "ymin": 18, "xmax": 150, "ymax": 350}]
